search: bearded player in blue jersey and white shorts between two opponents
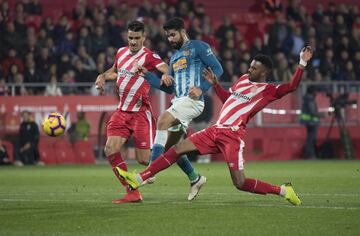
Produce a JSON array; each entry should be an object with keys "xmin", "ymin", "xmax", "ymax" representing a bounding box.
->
[{"xmin": 139, "ymin": 18, "xmax": 223, "ymax": 201}]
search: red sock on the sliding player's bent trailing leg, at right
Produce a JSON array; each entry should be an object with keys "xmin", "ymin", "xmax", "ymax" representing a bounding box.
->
[{"xmin": 241, "ymin": 178, "xmax": 280, "ymax": 195}]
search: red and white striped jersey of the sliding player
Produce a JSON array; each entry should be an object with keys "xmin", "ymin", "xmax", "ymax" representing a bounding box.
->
[{"xmin": 216, "ymin": 69, "xmax": 302, "ymax": 126}]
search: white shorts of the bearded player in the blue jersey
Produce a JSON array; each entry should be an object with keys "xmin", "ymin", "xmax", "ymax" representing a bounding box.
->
[{"xmin": 166, "ymin": 97, "xmax": 205, "ymax": 133}]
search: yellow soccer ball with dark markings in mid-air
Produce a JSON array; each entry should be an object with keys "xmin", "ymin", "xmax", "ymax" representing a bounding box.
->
[{"xmin": 42, "ymin": 112, "xmax": 66, "ymax": 137}]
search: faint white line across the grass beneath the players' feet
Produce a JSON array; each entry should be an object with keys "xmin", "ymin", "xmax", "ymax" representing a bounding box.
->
[{"xmin": 0, "ymin": 199, "xmax": 360, "ymax": 210}]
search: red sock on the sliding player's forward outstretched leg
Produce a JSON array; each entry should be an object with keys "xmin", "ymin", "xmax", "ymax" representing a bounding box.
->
[{"xmin": 140, "ymin": 148, "xmax": 179, "ymax": 181}]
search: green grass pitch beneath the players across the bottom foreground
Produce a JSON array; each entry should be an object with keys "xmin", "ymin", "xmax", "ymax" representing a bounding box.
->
[{"xmin": 0, "ymin": 161, "xmax": 360, "ymax": 236}]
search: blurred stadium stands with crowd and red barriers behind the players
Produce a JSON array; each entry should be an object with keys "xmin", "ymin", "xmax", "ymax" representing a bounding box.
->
[{"xmin": 0, "ymin": 0, "xmax": 360, "ymax": 165}]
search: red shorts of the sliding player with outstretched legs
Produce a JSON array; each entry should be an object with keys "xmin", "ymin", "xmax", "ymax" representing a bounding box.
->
[{"xmin": 189, "ymin": 125, "xmax": 245, "ymax": 170}]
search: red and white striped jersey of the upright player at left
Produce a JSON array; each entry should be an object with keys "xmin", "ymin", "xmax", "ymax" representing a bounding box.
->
[{"xmin": 114, "ymin": 47, "xmax": 164, "ymax": 112}]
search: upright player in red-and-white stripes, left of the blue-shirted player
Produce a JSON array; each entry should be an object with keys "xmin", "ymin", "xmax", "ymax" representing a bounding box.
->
[{"xmin": 95, "ymin": 21, "xmax": 171, "ymax": 204}]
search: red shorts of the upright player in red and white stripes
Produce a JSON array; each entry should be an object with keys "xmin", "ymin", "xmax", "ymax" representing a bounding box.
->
[{"xmin": 106, "ymin": 109, "xmax": 156, "ymax": 149}]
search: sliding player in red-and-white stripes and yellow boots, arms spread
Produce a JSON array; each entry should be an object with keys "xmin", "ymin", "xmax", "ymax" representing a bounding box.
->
[{"xmin": 118, "ymin": 47, "xmax": 313, "ymax": 205}]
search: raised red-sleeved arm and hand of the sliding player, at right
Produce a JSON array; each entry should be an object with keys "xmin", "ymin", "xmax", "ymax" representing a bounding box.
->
[{"xmin": 276, "ymin": 46, "xmax": 313, "ymax": 98}]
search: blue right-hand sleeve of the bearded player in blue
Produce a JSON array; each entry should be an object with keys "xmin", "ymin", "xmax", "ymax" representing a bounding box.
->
[{"xmin": 195, "ymin": 41, "xmax": 223, "ymax": 78}]
